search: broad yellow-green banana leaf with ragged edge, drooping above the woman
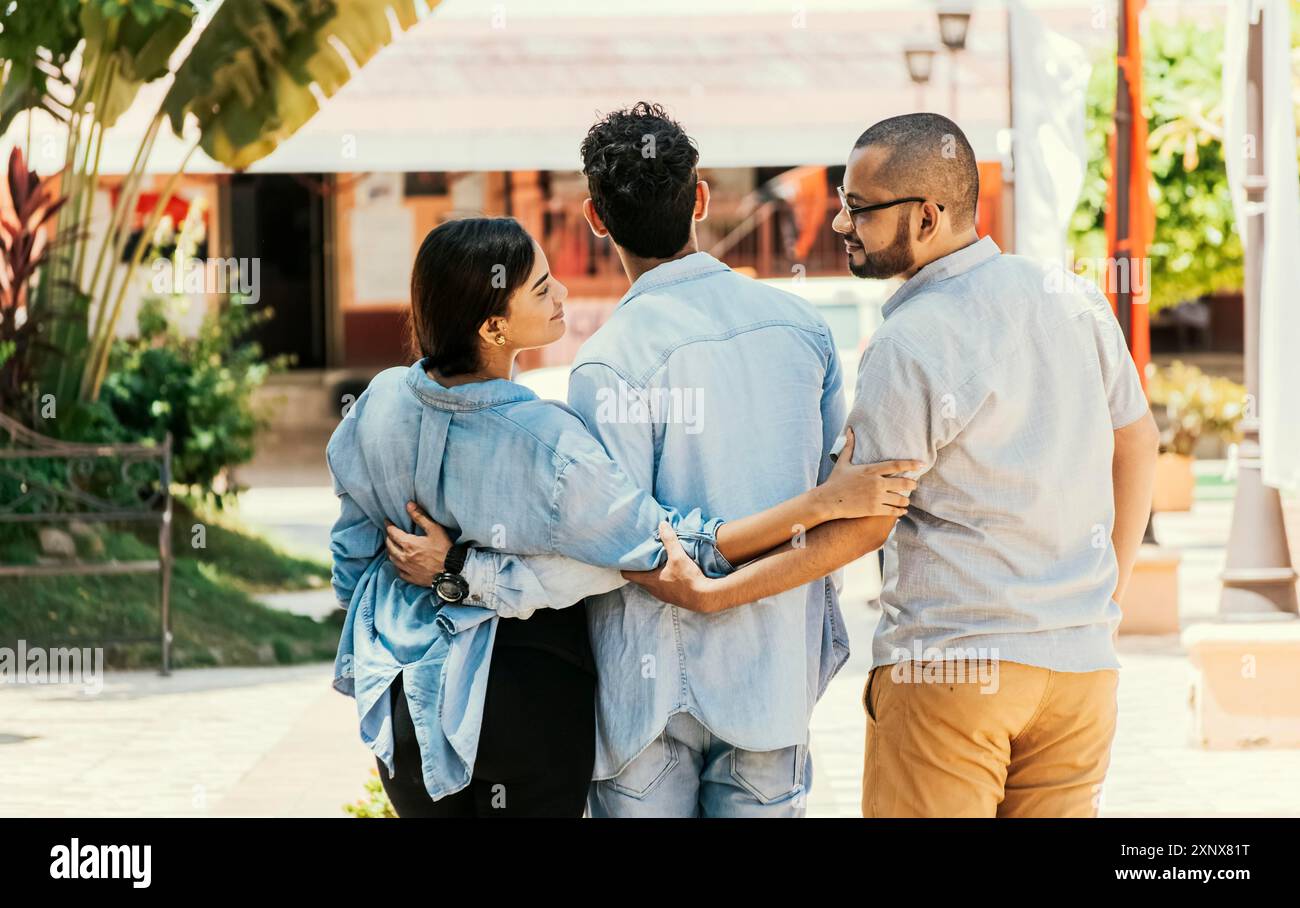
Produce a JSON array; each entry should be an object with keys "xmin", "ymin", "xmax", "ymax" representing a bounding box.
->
[{"xmin": 163, "ymin": 0, "xmax": 437, "ymax": 170}]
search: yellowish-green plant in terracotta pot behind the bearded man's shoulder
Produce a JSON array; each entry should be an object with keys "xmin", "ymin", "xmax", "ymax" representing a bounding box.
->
[{"xmin": 1147, "ymin": 360, "xmax": 1245, "ymax": 511}]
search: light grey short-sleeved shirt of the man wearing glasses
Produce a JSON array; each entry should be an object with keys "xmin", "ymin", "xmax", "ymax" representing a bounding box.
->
[{"xmin": 849, "ymin": 237, "xmax": 1148, "ymax": 671}]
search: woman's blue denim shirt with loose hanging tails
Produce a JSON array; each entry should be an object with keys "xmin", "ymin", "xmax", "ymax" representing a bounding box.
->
[{"xmin": 328, "ymin": 362, "xmax": 731, "ymax": 797}]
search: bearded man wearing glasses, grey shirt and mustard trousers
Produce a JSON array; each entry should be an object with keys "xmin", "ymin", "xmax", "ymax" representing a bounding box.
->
[{"xmin": 629, "ymin": 113, "xmax": 1157, "ymax": 817}]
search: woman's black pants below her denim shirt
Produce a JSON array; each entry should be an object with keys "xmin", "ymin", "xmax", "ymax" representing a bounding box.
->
[{"xmin": 380, "ymin": 647, "xmax": 595, "ymax": 817}]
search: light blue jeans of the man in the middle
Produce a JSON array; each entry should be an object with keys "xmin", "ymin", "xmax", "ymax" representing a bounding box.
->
[{"xmin": 588, "ymin": 713, "xmax": 813, "ymax": 817}]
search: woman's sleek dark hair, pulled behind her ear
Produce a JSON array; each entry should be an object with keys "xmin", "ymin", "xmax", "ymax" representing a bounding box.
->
[{"xmin": 411, "ymin": 217, "xmax": 536, "ymax": 376}]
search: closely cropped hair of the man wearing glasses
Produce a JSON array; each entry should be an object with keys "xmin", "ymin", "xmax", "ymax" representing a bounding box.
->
[{"xmin": 853, "ymin": 113, "xmax": 979, "ymax": 226}]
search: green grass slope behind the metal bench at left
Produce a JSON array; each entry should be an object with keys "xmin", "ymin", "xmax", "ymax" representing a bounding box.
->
[{"xmin": 0, "ymin": 501, "xmax": 342, "ymax": 667}]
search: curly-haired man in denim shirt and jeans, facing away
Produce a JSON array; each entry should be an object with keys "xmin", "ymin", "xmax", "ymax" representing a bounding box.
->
[{"xmin": 553, "ymin": 101, "xmax": 868, "ymax": 817}]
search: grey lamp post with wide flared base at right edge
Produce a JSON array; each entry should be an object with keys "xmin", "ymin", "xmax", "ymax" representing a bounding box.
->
[{"xmin": 1219, "ymin": 10, "xmax": 1296, "ymax": 619}]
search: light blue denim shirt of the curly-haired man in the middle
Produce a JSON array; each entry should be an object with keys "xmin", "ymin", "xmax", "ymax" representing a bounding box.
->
[{"xmin": 471, "ymin": 252, "xmax": 849, "ymax": 779}]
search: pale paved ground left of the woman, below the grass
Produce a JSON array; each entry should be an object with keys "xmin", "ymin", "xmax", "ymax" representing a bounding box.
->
[{"xmin": 0, "ymin": 665, "xmax": 373, "ymax": 817}]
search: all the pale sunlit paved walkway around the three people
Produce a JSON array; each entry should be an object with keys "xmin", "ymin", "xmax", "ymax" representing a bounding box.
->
[{"xmin": 0, "ymin": 478, "xmax": 1300, "ymax": 817}]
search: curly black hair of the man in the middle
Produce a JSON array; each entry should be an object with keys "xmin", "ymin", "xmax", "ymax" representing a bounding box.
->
[{"xmin": 581, "ymin": 101, "xmax": 699, "ymax": 259}]
